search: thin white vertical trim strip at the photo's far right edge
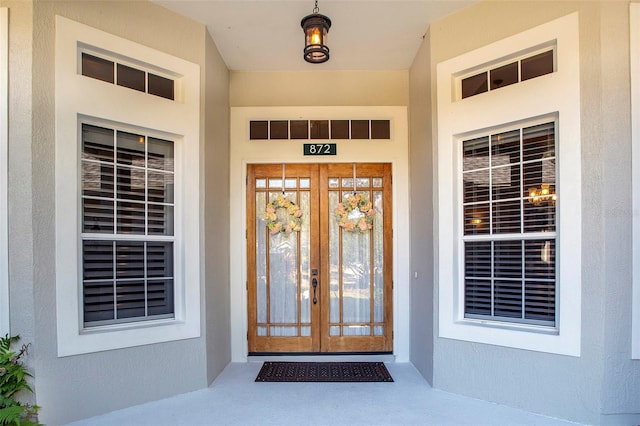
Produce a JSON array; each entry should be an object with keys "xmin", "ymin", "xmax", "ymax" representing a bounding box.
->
[{"xmin": 629, "ymin": 3, "xmax": 640, "ymax": 359}]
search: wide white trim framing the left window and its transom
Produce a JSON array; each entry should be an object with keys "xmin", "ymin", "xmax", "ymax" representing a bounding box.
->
[{"xmin": 55, "ymin": 16, "xmax": 203, "ymax": 356}]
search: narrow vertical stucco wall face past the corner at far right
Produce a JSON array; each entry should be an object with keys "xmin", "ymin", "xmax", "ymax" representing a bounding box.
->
[{"xmin": 597, "ymin": 2, "xmax": 640, "ymax": 424}]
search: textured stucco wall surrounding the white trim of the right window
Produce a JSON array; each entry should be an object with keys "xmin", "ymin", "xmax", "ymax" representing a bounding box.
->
[{"xmin": 424, "ymin": 1, "xmax": 640, "ymax": 424}]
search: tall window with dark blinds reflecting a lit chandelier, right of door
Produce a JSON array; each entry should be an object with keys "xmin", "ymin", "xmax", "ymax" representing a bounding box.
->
[{"xmin": 461, "ymin": 122, "xmax": 557, "ymax": 326}]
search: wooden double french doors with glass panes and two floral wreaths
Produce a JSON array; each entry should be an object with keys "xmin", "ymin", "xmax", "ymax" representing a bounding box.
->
[{"xmin": 247, "ymin": 163, "xmax": 393, "ymax": 354}]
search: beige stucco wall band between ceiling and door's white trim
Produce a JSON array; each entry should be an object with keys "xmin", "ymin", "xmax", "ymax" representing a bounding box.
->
[{"xmin": 230, "ymin": 69, "xmax": 409, "ymax": 107}]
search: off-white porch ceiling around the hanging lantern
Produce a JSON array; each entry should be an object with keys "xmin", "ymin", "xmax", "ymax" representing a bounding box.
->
[{"xmin": 153, "ymin": 0, "xmax": 477, "ymax": 71}]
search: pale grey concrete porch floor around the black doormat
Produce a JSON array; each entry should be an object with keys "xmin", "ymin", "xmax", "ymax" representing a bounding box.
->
[{"xmin": 65, "ymin": 362, "xmax": 575, "ymax": 426}]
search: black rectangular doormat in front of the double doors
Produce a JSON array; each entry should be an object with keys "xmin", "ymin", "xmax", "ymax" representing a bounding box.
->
[{"xmin": 256, "ymin": 361, "xmax": 393, "ymax": 382}]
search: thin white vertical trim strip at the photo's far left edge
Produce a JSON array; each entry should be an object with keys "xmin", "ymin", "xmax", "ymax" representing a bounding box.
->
[{"xmin": 0, "ymin": 7, "xmax": 10, "ymax": 336}]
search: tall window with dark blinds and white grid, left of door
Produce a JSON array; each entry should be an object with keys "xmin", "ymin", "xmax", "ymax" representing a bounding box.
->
[{"xmin": 81, "ymin": 123, "xmax": 175, "ymax": 326}]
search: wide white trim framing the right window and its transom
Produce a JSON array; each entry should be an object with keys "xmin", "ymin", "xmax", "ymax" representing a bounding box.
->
[{"xmin": 435, "ymin": 13, "xmax": 582, "ymax": 356}]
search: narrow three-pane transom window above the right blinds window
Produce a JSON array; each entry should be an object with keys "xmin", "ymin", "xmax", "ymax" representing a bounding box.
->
[{"xmin": 460, "ymin": 49, "xmax": 554, "ymax": 99}]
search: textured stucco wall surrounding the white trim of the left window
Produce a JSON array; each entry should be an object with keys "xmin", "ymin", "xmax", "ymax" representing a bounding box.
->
[{"xmin": 0, "ymin": 1, "xmax": 229, "ymax": 426}]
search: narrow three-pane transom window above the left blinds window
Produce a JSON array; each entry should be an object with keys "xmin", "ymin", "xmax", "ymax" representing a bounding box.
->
[{"xmin": 81, "ymin": 52, "xmax": 175, "ymax": 100}]
